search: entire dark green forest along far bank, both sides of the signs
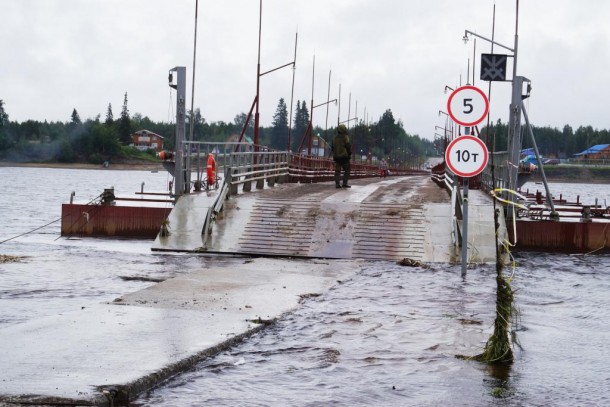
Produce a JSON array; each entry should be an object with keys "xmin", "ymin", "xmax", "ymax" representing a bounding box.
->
[{"xmin": 0, "ymin": 93, "xmax": 610, "ymax": 165}]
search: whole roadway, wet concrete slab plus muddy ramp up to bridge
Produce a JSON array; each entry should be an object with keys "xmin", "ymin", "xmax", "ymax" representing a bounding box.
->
[{"xmin": 0, "ymin": 176, "xmax": 502, "ymax": 405}]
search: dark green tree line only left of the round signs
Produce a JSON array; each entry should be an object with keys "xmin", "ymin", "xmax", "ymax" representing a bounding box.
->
[{"xmin": 0, "ymin": 93, "xmax": 434, "ymax": 164}]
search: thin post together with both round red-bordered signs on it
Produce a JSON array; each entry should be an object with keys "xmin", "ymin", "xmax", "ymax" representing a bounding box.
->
[{"xmin": 445, "ymin": 85, "xmax": 489, "ymax": 276}]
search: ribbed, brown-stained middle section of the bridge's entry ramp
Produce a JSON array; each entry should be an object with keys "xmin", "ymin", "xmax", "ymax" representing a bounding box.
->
[{"xmin": 239, "ymin": 199, "xmax": 426, "ymax": 260}]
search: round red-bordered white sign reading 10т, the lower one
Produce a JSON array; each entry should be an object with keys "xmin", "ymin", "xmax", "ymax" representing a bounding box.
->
[{"xmin": 445, "ymin": 136, "xmax": 489, "ymax": 178}]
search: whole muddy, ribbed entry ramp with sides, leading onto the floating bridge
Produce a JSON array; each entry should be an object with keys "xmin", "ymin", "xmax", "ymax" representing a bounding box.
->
[{"xmin": 153, "ymin": 176, "xmax": 495, "ymax": 263}]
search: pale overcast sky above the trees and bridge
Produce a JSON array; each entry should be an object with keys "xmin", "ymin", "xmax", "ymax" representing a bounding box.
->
[{"xmin": 0, "ymin": 0, "xmax": 610, "ymax": 139}]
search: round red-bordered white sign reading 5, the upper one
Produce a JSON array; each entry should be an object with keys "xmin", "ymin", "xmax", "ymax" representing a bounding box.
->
[{"xmin": 447, "ymin": 85, "xmax": 489, "ymax": 127}]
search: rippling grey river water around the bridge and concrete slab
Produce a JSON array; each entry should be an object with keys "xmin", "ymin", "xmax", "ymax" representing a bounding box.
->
[{"xmin": 0, "ymin": 167, "xmax": 610, "ymax": 406}]
